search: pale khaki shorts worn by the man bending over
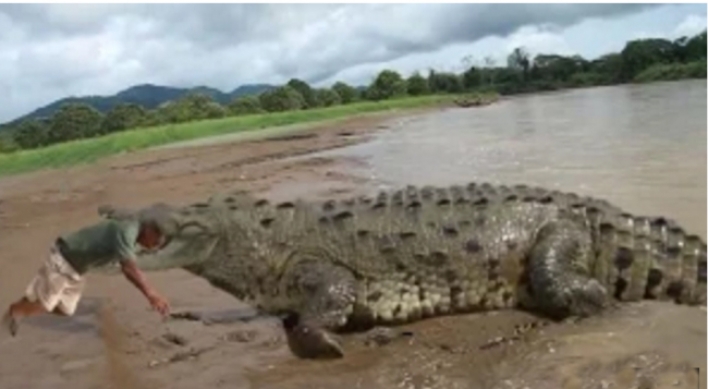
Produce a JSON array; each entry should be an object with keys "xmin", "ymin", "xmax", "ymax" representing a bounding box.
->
[{"xmin": 25, "ymin": 246, "xmax": 85, "ymax": 316}]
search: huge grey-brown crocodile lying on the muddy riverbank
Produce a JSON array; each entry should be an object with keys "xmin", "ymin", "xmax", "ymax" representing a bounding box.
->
[{"xmin": 99, "ymin": 182, "xmax": 706, "ymax": 358}]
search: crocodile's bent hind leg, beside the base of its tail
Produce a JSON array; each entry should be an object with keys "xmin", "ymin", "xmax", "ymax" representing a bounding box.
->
[{"xmin": 528, "ymin": 220, "xmax": 609, "ymax": 320}]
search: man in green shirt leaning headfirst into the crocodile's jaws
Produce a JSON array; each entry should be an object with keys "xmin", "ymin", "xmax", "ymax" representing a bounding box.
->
[{"xmin": 2, "ymin": 208, "xmax": 169, "ymax": 336}]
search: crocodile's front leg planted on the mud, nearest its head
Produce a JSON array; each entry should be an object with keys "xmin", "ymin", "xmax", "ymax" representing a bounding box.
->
[{"xmin": 276, "ymin": 262, "xmax": 356, "ymax": 358}]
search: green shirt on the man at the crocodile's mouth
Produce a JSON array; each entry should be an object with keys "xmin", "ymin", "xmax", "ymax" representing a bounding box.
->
[{"xmin": 59, "ymin": 219, "xmax": 140, "ymax": 274}]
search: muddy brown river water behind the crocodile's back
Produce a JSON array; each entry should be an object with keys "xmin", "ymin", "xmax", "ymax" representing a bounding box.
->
[{"xmin": 294, "ymin": 81, "xmax": 706, "ymax": 237}]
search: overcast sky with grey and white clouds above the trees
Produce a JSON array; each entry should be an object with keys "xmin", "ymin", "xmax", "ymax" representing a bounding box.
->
[{"xmin": 0, "ymin": 4, "xmax": 706, "ymax": 122}]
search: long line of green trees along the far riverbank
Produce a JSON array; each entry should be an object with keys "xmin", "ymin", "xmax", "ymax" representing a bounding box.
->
[{"xmin": 0, "ymin": 31, "xmax": 706, "ymax": 151}]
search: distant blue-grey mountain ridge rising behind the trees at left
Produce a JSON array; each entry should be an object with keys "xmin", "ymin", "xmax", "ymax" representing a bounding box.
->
[{"xmin": 2, "ymin": 84, "xmax": 275, "ymax": 127}]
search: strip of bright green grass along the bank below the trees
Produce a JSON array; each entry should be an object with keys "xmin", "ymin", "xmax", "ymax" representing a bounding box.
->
[{"xmin": 0, "ymin": 95, "xmax": 455, "ymax": 177}]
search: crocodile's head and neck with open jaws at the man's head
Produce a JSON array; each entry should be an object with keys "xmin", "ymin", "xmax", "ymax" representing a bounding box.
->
[{"xmin": 98, "ymin": 193, "xmax": 300, "ymax": 309}]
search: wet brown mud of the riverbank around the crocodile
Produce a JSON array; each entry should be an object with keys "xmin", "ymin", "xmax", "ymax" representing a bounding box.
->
[{"xmin": 0, "ymin": 106, "xmax": 706, "ymax": 389}]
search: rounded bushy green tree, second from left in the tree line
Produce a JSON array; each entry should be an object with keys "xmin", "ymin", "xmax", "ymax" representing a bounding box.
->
[{"xmin": 48, "ymin": 103, "xmax": 103, "ymax": 143}]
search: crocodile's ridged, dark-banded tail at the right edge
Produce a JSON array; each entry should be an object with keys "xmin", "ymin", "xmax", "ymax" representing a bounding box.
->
[{"xmin": 585, "ymin": 200, "xmax": 706, "ymax": 305}]
